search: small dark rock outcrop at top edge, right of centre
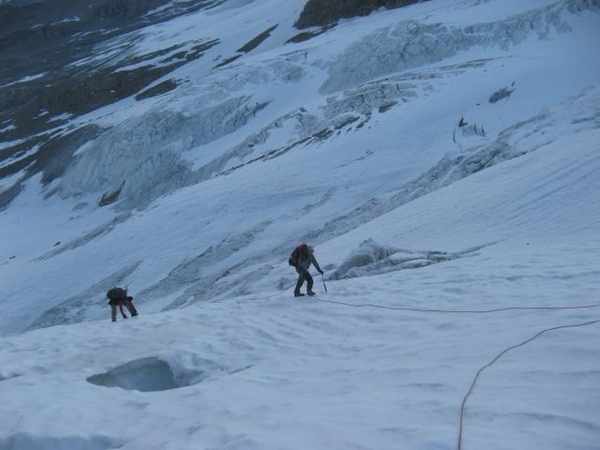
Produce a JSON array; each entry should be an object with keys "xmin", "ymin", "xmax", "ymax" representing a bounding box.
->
[{"xmin": 295, "ymin": 0, "xmax": 426, "ymax": 29}]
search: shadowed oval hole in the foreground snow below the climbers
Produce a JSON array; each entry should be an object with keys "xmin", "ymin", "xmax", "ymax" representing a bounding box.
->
[{"xmin": 87, "ymin": 356, "xmax": 221, "ymax": 392}]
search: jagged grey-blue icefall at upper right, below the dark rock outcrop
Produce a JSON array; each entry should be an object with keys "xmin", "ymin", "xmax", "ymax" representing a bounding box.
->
[{"xmin": 321, "ymin": 1, "xmax": 594, "ymax": 93}]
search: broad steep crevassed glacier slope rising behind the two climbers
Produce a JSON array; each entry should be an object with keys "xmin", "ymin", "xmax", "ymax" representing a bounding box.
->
[{"xmin": 0, "ymin": 0, "xmax": 600, "ymax": 332}]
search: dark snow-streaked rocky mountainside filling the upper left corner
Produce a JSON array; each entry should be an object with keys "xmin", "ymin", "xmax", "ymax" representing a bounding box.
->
[{"xmin": 0, "ymin": 0, "xmax": 224, "ymax": 210}]
